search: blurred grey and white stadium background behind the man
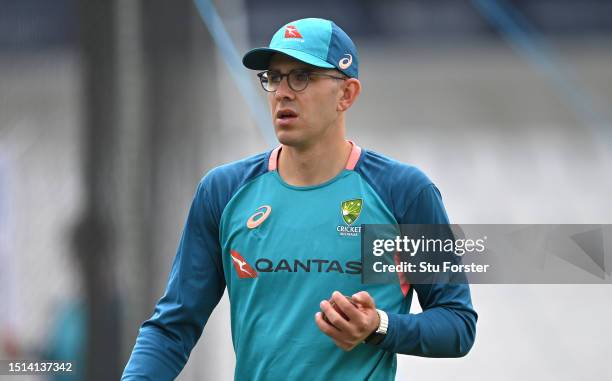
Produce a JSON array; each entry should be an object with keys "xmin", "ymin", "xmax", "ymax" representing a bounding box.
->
[{"xmin": 0, "ymin": 0, "xmax": 612, "ymax": 381}]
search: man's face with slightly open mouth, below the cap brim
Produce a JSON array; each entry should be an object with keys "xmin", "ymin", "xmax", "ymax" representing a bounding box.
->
[{"xmin": 268, "ymin": 54, "xmax": 343, "ymax": 147}]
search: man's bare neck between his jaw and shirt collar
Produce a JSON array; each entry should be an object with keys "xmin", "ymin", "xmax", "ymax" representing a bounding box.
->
[{"xmin": 278, "ymin": 138, "xmax": 352, "ymax": 186}]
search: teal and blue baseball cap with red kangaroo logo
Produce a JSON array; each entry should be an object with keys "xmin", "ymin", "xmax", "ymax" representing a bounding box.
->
[{"xmin": 242, "ymin": 18, "xmax": 359, "ymax": 78}]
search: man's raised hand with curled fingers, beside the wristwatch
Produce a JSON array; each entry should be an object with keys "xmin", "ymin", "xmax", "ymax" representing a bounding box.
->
[{"xmin": 315, "ymin": 291, "xmax": 380, "ymax": 351}]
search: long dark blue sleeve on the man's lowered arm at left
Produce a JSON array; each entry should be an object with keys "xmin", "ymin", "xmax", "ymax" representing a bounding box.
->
[{"xmin": 121, "ymin": 177, "xmax": 225, "ymax": 381}]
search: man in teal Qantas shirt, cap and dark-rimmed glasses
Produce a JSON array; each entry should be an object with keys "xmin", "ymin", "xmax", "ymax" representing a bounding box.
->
[{"xmin": 123, "ymin": 19, "xmax": 477, "ymax": 380}]
